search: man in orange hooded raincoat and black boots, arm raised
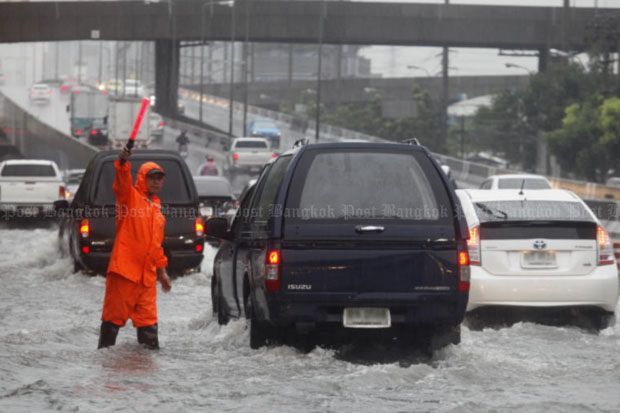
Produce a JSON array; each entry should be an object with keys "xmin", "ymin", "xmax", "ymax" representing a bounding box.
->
[{"xmin": 98, "ymin": 147, "xmax": 172, "ymax": 349}]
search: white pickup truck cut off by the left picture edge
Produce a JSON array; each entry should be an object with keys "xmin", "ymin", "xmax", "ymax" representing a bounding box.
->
[{"xmin": 0, "ymin": 159, "xmax": 65, "ymax": 219}]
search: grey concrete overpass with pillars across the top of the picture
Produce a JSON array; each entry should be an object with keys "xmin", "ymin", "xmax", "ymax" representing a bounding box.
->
[{"xmin": 0, "ymin": 0, "xmax": 596, "ymax": 115}]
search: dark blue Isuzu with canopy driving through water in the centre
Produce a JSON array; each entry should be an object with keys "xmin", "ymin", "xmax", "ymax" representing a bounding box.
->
[{"xmin": 206, "ymin": 142, "xmax": 469, "ymax": 348}]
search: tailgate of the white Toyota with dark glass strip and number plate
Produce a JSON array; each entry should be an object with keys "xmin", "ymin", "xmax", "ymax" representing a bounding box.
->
[{"xmin": 480, "ymin": 221, "xmax": 597, "ymax": 275}]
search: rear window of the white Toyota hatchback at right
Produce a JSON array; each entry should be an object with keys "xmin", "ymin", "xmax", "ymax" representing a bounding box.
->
[{"xmin": 474, "ymin": 201, "xmax": 594, "ymax": 223}]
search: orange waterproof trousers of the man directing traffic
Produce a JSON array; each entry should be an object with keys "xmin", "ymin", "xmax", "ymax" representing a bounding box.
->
[{"xmin": 101, "ymin": 273, "xmax": 157, "ymax": 327}]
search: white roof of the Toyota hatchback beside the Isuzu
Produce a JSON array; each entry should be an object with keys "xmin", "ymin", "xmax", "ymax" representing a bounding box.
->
[{"xmin": 457, "ymin": 189, "xmax": 580, "ymax": 202}]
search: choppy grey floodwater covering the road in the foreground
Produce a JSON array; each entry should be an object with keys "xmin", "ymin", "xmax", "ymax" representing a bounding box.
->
[{"xmin": 0, "ymin": 224, "xmax": 620, "ymax": 413}]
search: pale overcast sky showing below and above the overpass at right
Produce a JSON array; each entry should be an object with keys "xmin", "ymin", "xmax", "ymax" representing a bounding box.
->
[{"xmin": 356, "ymin": 0, "xmax": 620, "ymax": 77}]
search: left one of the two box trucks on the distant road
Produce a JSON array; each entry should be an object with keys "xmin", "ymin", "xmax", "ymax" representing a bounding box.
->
[{"xmin": 67, "ymin": 86, "xmax": 108, "ymax": 140}]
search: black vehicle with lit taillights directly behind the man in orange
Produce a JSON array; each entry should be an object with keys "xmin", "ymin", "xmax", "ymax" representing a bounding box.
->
[{"xmin": 55, "ymin": 150, "xmax": 205, "ymax": 275}]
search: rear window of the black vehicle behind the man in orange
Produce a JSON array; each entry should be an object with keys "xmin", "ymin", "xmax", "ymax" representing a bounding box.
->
[{"xmin": 93, "ymin": 160, "xmax": 192, "ymax": 205}]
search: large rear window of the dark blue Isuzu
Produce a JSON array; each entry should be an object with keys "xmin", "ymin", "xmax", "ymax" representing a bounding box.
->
[{"xmin": 287, "ymin": 149, "xmax": 451, "ymax": 224}]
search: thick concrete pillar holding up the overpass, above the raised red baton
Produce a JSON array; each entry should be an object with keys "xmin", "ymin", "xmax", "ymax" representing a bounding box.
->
[{"xmin": 155, "ymin": 40, "xmax": 179, "ymax": 117}]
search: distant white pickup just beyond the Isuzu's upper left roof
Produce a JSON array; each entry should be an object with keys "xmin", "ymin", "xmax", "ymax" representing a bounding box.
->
[{"xmin": 228, "ymin": 138, "xmax": 277, "ymax": 177}]
